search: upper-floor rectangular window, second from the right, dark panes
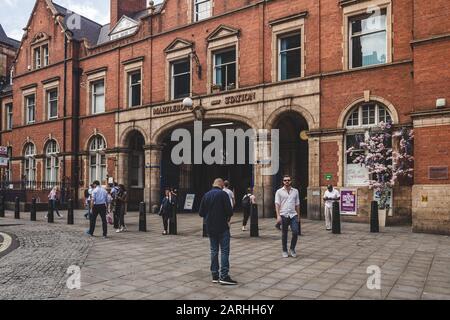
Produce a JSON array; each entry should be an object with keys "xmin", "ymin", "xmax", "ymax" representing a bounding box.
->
[{"xmin": 278, "ymin": 33, "xmax": 302, "ymax": 80}]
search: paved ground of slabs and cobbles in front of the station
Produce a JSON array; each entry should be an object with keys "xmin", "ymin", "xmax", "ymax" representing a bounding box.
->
[{"xmin": 0, "ymin": 212, "xmax": 450, "ymax": 300}]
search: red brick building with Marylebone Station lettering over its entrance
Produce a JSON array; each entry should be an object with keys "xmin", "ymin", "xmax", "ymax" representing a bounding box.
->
[{"xmin": 1, "ymin": 0, "xmax": 450, "ymax": 234}]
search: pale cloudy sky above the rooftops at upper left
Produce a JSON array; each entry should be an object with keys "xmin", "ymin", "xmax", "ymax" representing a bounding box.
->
[{"xmin": 0, "ymin": 0, "xmax": 161, "ymax": 40}]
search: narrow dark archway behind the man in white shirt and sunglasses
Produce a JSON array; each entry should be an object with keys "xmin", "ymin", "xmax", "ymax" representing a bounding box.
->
[{"xmin": 273, "ymin": 111, "xmax": 309, "ymax": 217}]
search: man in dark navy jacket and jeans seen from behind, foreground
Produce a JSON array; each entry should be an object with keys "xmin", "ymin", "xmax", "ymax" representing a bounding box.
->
[{"xmin": 200, "ymin": 179, "xmax": 237, "ymax": 285}]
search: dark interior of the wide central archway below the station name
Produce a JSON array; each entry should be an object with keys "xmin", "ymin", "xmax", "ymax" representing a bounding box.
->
[{"xmin": 161, "ymin": 120, "xmax": 253, "ymax": 211}]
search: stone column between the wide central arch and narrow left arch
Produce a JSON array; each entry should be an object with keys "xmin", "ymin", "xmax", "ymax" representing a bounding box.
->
[{"xmin": 144, "ymin": 145, "xmax": 163, "ymax": 212}]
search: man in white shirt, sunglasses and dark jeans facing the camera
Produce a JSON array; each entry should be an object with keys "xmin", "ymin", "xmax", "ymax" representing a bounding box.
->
[{"xmin": 275, "ymin": 176, "xmax": 300, "ymax": 258}]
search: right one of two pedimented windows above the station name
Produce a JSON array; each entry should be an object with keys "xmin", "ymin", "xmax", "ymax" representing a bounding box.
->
[{"xmin": 214, "ymin": 48, "xmax": 237, "ymax": 91}]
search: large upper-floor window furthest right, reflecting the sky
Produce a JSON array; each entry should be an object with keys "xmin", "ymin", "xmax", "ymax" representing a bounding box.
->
[{"xmin": 349, "ymin": 9, "xmax": 388, "ymax": 68}]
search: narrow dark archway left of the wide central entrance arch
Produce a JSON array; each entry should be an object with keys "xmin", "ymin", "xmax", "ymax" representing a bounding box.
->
[{"xmin": 127, "ymin": 130, "xmax": 145, "ymax": 211}]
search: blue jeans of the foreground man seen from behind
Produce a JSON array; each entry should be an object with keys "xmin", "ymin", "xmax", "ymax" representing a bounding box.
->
[{"xmin": 209, "ymin": 230, "xmax": 231, "ymax": 279}]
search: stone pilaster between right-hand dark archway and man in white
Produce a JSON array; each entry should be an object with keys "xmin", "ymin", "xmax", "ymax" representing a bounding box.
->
[{"xmin": 308, "ymin": 137, "xmax": 322, "ymax": 220}]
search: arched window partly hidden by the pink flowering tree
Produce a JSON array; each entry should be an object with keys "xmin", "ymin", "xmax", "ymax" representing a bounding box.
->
[{"xmin": 345, "ymin": 102, "xmax": 392, "ymax": 186}]
